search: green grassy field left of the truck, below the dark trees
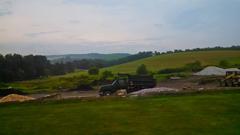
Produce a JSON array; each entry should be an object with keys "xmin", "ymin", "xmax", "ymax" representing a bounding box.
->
[{"xmin": 7, "ymin": 71, "xmax": 98, "ymax": 93}]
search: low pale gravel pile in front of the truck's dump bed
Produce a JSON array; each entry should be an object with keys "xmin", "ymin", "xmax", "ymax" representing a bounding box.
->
[{"xmin": 130, "ymin": 87, "xmax": 179, "ymax": 96}]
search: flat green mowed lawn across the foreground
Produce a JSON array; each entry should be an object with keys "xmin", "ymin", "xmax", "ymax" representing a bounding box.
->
[{"xmin": 0, "ymin": 91, "xmax": 240, "ymax": 135}]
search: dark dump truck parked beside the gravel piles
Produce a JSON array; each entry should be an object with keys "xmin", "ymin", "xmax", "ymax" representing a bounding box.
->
[{"xmin": 99, "ymin": 74, "xmax": 156, "ymax": 96}]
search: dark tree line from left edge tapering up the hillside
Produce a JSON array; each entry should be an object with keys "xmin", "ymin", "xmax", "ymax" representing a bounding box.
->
[{"xmin": 0, "ymin": 52, "xmax": 151, "ymax": 82}]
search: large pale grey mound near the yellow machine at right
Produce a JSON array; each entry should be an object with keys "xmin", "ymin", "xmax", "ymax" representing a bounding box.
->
[{"xmin": 194, "ymin": 66, "xmax": 226, "ymax": 76}]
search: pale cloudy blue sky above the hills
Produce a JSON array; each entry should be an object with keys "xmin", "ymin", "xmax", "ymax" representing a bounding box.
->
[{"xmin": 0, "ymin": 0, "xmax": 240, "ymax": 55}]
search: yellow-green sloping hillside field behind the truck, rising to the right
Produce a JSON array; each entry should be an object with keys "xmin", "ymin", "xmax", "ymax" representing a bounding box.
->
[{"xmin": 105, "ymin": 50, "xmax": 240, "ymax": 73}]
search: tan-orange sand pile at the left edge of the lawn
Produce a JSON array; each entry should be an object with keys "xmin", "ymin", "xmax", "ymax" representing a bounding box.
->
[{"xmin": 0, "ymin": 94, "xmax": 34, "ymax": 103}]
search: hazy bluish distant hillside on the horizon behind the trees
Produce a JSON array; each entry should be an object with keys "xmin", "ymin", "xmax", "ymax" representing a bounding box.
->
[{"xmin": 47, "ymin": 53, "xmax": 130, "ymax": 63}]
